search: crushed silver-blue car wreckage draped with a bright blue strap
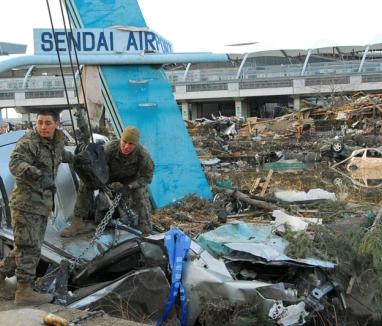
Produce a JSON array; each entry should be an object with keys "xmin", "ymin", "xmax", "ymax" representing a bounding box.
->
[{"xmin": 0, "ymin": 131, "xmax": 346, "ymax": 325}]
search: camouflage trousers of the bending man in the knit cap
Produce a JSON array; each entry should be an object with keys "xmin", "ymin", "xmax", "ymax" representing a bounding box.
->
[{"xmin": 73, "ymin": 182, "xmax": 152, "ymax": 233}]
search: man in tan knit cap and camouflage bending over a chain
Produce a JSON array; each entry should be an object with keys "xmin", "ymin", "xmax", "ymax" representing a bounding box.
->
[{"xmin": 61, "ymin": 127, "xmax": 154, "ymax": 237}]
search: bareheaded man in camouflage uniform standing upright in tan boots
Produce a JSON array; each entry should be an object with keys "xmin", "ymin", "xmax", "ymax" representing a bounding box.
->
[{"xmin": 0, "ymin": 111, "xmax": 73, "ymax": 304}]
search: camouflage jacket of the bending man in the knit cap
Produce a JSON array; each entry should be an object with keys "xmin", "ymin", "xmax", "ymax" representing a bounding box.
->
[{"xmin": 105, "ymin": 140, "xmax": 154, "ymax": 189}]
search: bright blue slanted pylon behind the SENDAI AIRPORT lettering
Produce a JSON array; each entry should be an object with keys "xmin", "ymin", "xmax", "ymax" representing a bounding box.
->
[{"xmin": 71, "ymin": 0, "xmax": 212, "ymax": 207}]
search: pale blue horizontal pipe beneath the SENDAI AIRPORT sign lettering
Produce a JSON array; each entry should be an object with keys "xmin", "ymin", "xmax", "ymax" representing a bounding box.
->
[{"xmin": 0, "ymin": 53, "xmax": 228, "ymax": 72}]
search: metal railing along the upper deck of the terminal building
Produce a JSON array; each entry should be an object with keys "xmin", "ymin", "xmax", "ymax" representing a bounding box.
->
[{"xmin": 0, "ymin": 59, "xmax": 382, "ymax": 96}]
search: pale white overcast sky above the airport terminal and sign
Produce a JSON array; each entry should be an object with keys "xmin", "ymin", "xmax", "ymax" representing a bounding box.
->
[{"xmin": 0, "ymin": 0, "xmax": 382, "ymax": 53}]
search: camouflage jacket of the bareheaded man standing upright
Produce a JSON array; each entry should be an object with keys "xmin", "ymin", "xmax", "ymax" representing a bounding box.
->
[{"xmin": 9, "ymin": 130, "xmax": 73, "ymax": 216}]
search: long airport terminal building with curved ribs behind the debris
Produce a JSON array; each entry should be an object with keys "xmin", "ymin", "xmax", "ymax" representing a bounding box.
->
[{"xmin": 0, "ymin": 43, "xmax": 382, "ymax": 119}]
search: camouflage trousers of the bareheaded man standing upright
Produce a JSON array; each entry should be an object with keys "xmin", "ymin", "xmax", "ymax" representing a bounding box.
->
[{"xmin": 0, "ymin": 209, "xmax": 48, "ymax": 284}]
